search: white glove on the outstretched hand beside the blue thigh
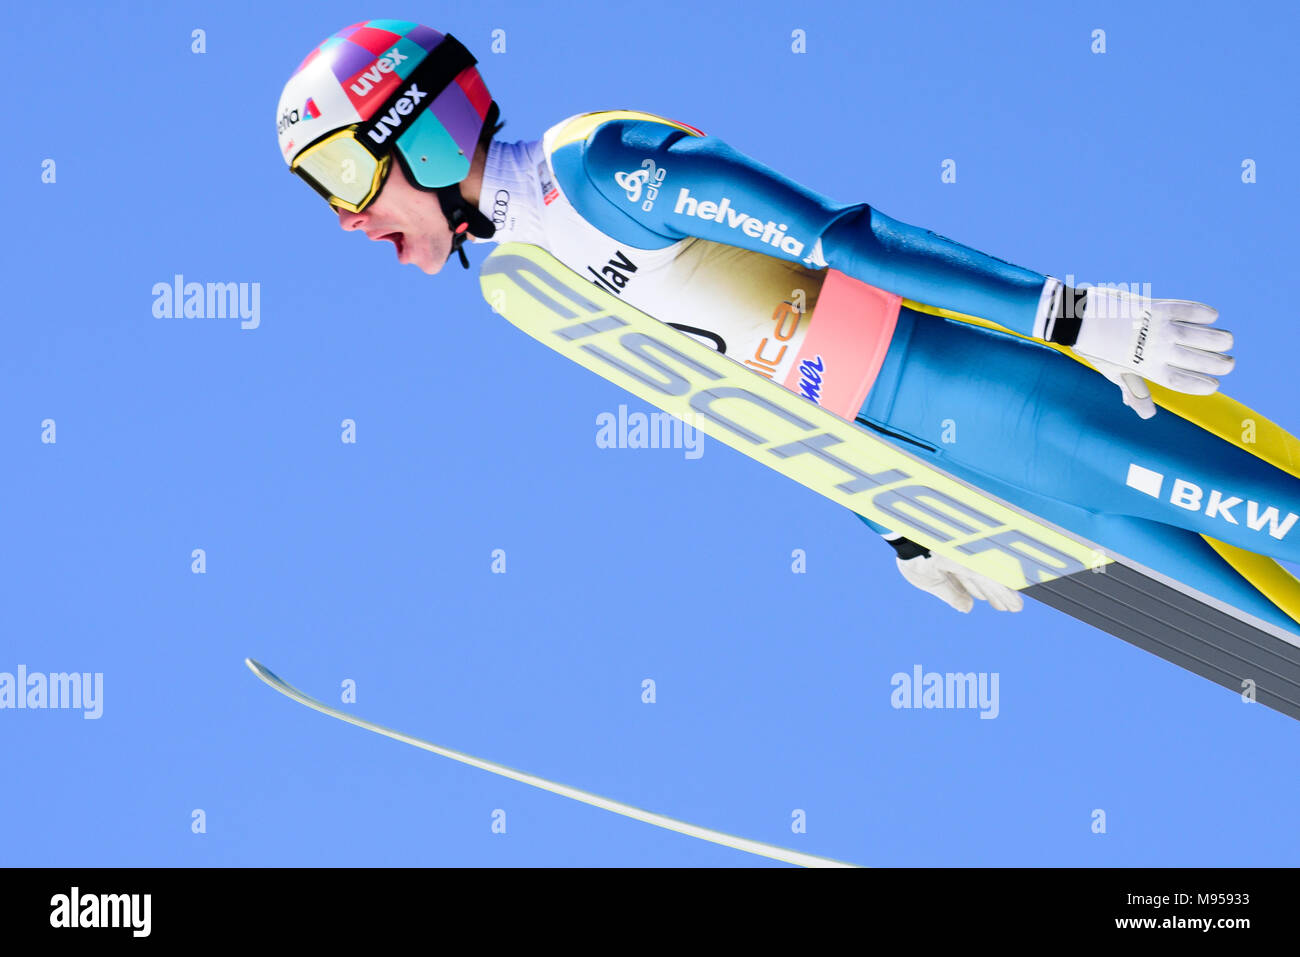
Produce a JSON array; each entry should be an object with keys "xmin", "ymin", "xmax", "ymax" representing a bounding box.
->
[{"xmin": 1073, "ymin": 286, "xmax": 1236, "ymax": 419}]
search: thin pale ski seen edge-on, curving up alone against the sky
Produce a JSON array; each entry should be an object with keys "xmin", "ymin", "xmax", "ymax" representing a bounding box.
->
[{"xmin": 244, "ymin": 658, "xmax": 857, "ymax": 867}]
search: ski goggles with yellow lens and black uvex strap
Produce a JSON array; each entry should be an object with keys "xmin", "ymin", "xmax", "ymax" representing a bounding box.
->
[{"xmin": 289, "ymin": 34, "xmax": 481, "ymax": 213}]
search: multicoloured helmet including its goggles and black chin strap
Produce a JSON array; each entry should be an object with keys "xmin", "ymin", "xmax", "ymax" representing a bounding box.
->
[{"xmin": 276, "ymin": 20, "xmax": 499, "ymax": 265}]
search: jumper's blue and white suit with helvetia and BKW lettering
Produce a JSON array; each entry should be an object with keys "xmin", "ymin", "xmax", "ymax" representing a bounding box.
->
[{"xmin": 480, "ymin": 111, "xmax": 1300, "ymax": 619}]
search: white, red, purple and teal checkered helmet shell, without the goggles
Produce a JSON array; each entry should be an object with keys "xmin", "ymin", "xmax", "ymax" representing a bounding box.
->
[{"xmin": 276, "ymin": 20, "xmax": 497, "ymax": 189}]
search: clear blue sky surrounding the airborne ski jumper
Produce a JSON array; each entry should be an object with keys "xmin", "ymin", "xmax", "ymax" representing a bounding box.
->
[{"xmin": 0, "ymin": 0, "xmax": 1300, "ymax": 866}]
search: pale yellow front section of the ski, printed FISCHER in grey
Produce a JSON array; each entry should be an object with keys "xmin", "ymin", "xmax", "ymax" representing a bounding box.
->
[{"xmin": 480, "ymin": 243, "xmax": 1110, "ymax": 589}]
